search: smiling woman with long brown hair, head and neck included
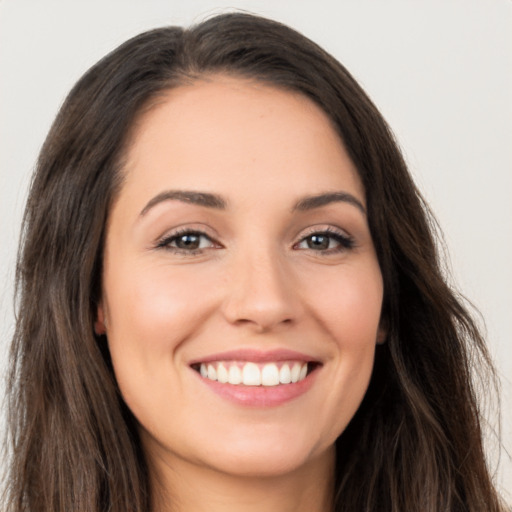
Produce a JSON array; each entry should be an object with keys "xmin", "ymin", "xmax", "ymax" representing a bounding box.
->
[{"xmin": 7, "ymin": 14, "xmax": 508, "ymax": 512}]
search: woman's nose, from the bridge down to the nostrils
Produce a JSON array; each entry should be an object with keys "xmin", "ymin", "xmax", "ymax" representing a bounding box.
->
[{"xmin": 223, "ymin": 247, "xmax": 301, "ymax": 332}]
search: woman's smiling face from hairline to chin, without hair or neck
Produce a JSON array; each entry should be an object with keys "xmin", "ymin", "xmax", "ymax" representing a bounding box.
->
[{"xmin": 96, "ymin": 76, "xmax": 384, "ymax": 475}]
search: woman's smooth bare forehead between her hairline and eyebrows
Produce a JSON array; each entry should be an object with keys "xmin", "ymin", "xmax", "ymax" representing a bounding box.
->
[{"xmin": 119, "ymin": 76, "xmax": 364, "ymax": 206}]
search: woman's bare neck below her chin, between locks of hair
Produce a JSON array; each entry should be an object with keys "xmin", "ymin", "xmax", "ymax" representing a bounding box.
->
[{"xmin": 151, "ymin": 447, "xmax": 334, "ymax": 512}]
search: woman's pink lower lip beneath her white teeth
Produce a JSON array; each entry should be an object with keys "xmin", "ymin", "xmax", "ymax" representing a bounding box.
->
[{"xmin": 194, "ymin": 369, "xmax": 318, "ymax": 407}]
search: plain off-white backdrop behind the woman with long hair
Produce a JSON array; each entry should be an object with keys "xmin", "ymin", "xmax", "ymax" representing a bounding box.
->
[{"xmin": 0, "ymin": 0, "xmax": 512, "ymax": 501}]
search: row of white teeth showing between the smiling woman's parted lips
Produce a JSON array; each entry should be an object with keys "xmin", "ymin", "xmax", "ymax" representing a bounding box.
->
[{"xmin": 192, "ymin": 361, "xmax": 319, "ymax": 387}]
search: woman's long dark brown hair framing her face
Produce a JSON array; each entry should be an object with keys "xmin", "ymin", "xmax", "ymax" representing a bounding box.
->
[{"xmin": 7, "ymin": 14, "xmax": 501, "ymax": 512}]
